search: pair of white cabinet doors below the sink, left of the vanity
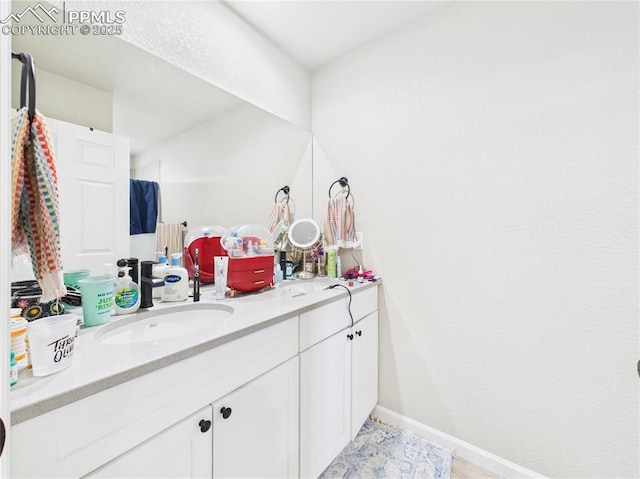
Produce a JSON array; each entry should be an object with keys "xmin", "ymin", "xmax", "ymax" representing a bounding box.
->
[{"xmin": 85, "ymin": 357, "xmax": 298, "ymax": 479}]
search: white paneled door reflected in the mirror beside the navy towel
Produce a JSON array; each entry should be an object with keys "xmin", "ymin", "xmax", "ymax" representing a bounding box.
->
[{"xmin": 47, "ymin": 118, "xmax": 129, "ymax": 274}]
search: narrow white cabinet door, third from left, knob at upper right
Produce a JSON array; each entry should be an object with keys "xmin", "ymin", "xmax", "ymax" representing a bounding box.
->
[{"xmin": 300, "ymin": 330, "xmax": 352, "ymax": 478}]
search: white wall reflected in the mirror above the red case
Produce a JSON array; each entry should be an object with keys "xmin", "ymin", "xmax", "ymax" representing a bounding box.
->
[{"xmin": 133, "ymin": 104, "xmax": 311, "ymax": 231}]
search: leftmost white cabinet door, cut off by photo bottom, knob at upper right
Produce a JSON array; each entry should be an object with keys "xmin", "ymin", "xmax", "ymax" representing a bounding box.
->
[{"xmin": 85, "ymin": 406, "xmax": 212, "ymax": 479}]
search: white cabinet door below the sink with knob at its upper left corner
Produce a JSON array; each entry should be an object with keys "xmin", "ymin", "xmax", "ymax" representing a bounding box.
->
[{"xmin": 213, "ymin": 356, "xmax": 299, "ymax": 478}]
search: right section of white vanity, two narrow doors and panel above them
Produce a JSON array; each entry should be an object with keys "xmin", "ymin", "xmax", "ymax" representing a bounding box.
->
[{"xmin": 300, "ymin": 288, "xmax": 378, "ymax": 478}]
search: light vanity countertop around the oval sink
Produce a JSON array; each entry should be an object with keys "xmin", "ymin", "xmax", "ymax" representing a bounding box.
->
[{"xmin": 9, "ymin": 278, "xmax": 380, "ymax": 425}]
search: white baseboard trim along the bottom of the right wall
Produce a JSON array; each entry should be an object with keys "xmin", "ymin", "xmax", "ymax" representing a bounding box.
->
[{"xmin": 371, "ymin": 405, "xmax": 546, "ymax": 479}]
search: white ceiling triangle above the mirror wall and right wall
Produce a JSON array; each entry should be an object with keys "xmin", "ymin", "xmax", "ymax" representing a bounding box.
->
[{"xmin": 225, "ymin": 0, "xmax": 453, "ymax": 71}]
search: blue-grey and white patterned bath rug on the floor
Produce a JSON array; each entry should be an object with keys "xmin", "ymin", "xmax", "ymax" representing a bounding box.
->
[{"xmin": 319, "ymin": 419, "xmax": 452, "ymax": 479}]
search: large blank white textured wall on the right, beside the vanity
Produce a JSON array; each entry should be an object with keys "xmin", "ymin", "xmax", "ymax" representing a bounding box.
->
[{"xmin": 312, "ymin": 2, "xmax": 640, "ymax": 477}]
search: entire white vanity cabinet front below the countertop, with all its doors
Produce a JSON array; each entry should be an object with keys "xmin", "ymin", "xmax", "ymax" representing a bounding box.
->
[{"xmin": 11, "ymin": 287, "xmax": 378, "ymax": 479}]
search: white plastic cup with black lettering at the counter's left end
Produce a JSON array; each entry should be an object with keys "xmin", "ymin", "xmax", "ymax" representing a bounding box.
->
[{"xmin": 27, "ymin": 314, "xmax": 78, "ymax": 376}]
